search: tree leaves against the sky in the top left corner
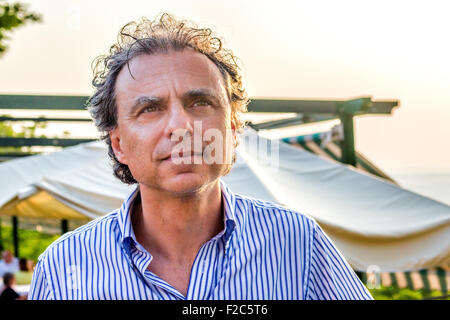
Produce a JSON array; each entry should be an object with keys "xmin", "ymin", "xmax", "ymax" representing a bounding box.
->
[{"xmin": 0, "ymin": 1, "xmax": 42, "ymax": 56}]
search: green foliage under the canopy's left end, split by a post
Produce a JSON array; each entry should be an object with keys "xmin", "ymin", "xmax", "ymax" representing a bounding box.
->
[{"xmin": 2, "ymin": 225, "xmax": 60, "ymax": 261}]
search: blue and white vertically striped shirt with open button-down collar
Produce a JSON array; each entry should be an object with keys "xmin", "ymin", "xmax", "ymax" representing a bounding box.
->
[{"xmin": 29, "ymin": 179, "xmax": 372, "ymax": 300}]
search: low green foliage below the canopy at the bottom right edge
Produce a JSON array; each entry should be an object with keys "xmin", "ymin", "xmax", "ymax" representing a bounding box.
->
[{"xmin": 369, "ymin": 286, "xmax": 450, "ymax": 300}]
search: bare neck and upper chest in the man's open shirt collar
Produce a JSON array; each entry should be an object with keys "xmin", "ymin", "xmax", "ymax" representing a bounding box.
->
[{"xmin": 132, "ymin": 180, "xmax": 224, "ymax": 263}]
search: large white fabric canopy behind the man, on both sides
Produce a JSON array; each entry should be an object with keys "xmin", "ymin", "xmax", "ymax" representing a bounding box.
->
[{"xmin": 0, "ymin": 128, "xmax": 450, "ymax": 272}]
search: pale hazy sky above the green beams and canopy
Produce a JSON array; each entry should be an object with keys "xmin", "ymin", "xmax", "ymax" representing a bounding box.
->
[{"xmin": 0, "ymin": 0, "xmax": 450, "ymax": 202}]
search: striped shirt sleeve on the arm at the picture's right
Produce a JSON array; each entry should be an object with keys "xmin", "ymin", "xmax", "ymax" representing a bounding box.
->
[{"xmin": 306, "ymin": 223, "xmax": 373, "ymax": 300}]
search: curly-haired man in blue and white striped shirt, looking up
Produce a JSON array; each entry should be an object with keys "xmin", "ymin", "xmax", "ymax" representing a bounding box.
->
[{"xmin": 29, "ymin": 14, "xmax": 371, "ymax": 299}]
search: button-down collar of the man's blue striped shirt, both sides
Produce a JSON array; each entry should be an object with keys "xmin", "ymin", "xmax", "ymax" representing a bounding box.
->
[{"xmin": 118, "ymin": 179, "xmax": 241, "ymax": 259}]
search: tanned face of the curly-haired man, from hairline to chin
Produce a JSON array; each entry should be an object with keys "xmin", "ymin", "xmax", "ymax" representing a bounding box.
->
[{"xmin": 110, "ymin": 49, "xmax": 235, "ymax": 194}]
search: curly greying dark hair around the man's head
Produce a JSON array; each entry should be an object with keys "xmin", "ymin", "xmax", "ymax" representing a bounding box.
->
[{"xmin": 88, "ymin": 13, "xmax": 248, "ymax": 184}]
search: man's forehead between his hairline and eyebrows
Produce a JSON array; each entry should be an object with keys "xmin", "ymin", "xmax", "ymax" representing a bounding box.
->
[{"xmin": 115, "ymin": 49, "xmax": 226, "ymax": 100}]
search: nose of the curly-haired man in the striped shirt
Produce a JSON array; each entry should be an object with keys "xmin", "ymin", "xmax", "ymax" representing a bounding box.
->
[{"xmin": 165, "ymin": 101, "xmax": 194, "ymax": 139}]
